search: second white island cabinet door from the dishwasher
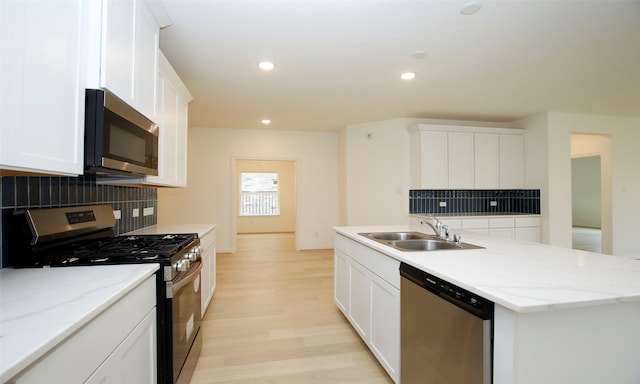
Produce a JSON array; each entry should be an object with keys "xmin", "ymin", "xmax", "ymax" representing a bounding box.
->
[{"xmin": 348, "ymin": 262, "xmax": 371, "ymax": 341}]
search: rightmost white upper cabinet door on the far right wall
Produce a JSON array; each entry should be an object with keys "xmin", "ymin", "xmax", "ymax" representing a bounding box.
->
[{"xmin": 500, "ymin": 135, "xmax": 524, "ymax": 189}]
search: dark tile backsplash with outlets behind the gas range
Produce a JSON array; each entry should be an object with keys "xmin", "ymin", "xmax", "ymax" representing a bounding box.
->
[{"xmin": 0, "ymin": 175, "xmax": 158, "ymax": 266}]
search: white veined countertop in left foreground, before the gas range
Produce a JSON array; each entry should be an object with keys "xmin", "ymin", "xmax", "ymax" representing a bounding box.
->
[{"xmin": 0, "ymin": 263, "xmax": 159, "ymax": 383}]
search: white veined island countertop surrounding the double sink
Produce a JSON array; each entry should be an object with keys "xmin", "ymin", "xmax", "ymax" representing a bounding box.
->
[{"xmin": 335, "ymin": 226, "xmax": 640, "ymax": 313}]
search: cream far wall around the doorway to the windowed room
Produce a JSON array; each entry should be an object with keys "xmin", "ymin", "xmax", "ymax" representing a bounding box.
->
[{"xmin": 158, "ymin": 128, "xmax": 338, "ymax": 252}]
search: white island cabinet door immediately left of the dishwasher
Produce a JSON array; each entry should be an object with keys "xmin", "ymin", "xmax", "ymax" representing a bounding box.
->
[{"xmin": 370, "ymin": 275, "xmax": 400, "ymax": 382}]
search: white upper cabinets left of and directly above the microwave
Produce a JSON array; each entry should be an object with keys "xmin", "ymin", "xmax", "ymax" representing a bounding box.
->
[{"xmin": 0, "ymin": 0, "xmax": 169, "ymax": 176}]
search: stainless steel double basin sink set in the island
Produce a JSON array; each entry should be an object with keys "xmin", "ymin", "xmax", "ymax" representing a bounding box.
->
[{"xmin": 358, "ymin": 232, "xmax": 484, "ymax": 252}]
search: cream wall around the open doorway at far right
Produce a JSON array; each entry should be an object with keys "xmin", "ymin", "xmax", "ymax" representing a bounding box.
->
[{"xmin": 516, "ymin": 112, "xmax": 640, "ymax": 256}]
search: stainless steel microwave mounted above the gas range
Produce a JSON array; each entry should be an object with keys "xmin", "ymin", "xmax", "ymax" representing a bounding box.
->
[{"xmin": 84, "ymin": 89, "xmax": 159, "ymax": 177}]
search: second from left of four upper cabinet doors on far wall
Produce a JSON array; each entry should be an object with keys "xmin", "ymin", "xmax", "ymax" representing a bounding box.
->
[{"xmin": 447, "ymin": 132, "xmax": 474, "ymax": 189}]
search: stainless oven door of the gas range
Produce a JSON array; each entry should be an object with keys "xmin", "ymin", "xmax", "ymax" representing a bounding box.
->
[{"xmin": 167, "ymin": 260, "xmax": 202, "ymax": 383}]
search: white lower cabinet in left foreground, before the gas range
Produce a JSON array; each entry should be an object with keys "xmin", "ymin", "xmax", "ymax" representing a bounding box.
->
[{"xmin": 9, "ymin": 275, "xmax": 157, "ymax": 384}]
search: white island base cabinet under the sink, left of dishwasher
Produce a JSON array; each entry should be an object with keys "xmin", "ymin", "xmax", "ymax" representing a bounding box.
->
[{"xmin": 334, "ymin": 234, "xmax": 400, "ymax": 383}]
